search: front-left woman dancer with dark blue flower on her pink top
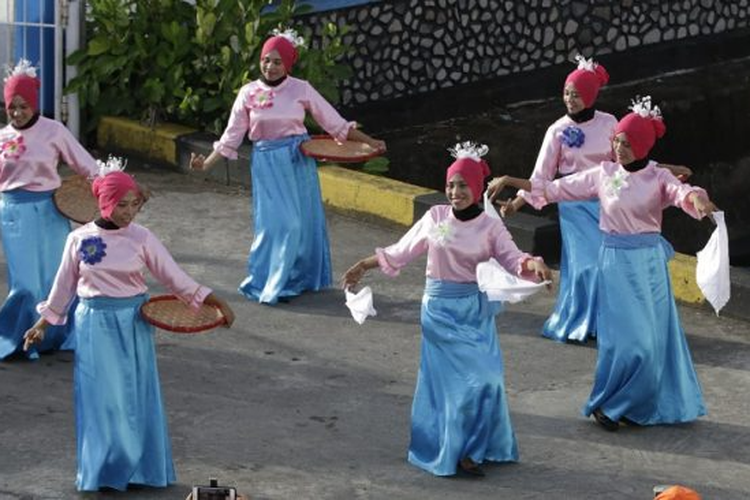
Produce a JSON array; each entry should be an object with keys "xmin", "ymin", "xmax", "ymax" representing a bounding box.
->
[{"xmin": 24, "ymin": 165, "xmax": 234, "ymax": 491}]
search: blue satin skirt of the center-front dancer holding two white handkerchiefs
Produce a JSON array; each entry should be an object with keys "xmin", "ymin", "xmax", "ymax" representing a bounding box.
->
[{"xmin": 408, "ymin": 279, "xmax": 518, "ymax": 476}]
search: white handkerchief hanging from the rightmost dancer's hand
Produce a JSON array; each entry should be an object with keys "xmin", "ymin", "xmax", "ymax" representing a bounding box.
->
[{"xmin": 695, "ymin": 212, "xmax": 731, "ymax": 316}]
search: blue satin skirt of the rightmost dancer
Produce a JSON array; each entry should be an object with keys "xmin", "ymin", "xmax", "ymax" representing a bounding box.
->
[{"xmin": 583, "ymin": 233, "xmax": 706, "ymax": 425}]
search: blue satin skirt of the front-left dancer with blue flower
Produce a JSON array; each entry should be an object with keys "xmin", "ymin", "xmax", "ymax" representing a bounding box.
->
[{"xmin": 75, "ymin": 295, "xmax": 176, "ymax": 491}]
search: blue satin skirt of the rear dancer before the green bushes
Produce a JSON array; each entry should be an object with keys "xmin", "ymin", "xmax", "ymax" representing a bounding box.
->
[{"xmin": 239, "ymin": 135, "xmax": 333, "ymax": 304}]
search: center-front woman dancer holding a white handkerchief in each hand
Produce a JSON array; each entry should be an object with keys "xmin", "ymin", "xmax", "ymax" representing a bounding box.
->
[{"xmin": 342, "ymin": 143, "xmax": 550, "ymax": 476}]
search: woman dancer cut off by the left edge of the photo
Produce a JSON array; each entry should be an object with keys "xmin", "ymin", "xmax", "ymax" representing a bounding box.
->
[{"xmin": 0, "ymin": 59, "xmax": 98, "ymax": 359}]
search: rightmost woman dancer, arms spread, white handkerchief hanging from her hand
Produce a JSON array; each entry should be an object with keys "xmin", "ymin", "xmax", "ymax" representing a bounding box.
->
[{"xmin": 499, "ymin": 97, "xmax": 716, "ymax": 431}]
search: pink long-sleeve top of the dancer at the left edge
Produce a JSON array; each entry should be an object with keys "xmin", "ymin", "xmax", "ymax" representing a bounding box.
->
[{"xmin": 0, "ymin": 116, "xmax": 99, "ymax": 191}]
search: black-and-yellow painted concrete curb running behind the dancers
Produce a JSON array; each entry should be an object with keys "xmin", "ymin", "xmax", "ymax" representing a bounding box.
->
[{"xmin": 97, "ymin": 117, "xmax": 750, "ymax": 320}]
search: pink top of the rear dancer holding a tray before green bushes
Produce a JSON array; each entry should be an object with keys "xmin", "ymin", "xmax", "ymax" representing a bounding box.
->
[{"xmin": 214, "ymin": 76, "xmax": 355, "ymax": 160}]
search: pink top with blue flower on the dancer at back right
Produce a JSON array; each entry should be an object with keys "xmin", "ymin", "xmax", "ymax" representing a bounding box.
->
[{"xmin": 518, "ymin": 111, "xmax": 617, "ymax": 210}]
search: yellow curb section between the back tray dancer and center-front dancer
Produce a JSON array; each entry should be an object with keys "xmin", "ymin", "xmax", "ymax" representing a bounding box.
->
[{"xmin": 318, "ymin": 165, "xmax": 435, "ymax": 226}]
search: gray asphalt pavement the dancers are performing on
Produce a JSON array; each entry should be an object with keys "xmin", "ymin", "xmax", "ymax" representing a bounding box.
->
[{"xmin": 0, "ymin": 166, "xmax": 750, "ymax": 500}]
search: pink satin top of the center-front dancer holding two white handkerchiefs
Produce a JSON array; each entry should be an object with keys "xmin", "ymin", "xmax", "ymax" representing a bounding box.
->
[{"xmin": 375, "ymin": 205, "xmax": 534, "ymax": 283}]
